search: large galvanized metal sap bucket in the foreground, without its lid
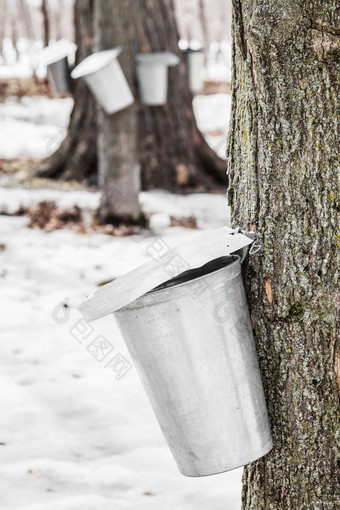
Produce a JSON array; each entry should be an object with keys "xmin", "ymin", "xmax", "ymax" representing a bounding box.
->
[{"xmin": 114, "ymin": 256, "xmax": 272, "ymax": 476}]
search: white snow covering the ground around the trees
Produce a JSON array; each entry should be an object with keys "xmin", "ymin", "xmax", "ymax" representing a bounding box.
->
[{"xmin": 0, "ymin": 85, "xmax": 241, "ymax": 510}]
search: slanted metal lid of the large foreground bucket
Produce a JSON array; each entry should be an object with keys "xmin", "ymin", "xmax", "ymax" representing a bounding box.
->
[{"xmin": 79, "ymin": 227, "xmax": 253, "ymax": 322}]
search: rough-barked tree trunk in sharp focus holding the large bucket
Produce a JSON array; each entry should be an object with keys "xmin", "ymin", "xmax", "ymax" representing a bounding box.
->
[{"xmin": 228, "ymin": 0, "xmax": 340, "ymax": 510}]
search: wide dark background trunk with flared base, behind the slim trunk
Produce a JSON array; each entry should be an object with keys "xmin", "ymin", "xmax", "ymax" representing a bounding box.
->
[{"xmin": 38, "ymin": 0, "xmax": 226, "ymax": 189}]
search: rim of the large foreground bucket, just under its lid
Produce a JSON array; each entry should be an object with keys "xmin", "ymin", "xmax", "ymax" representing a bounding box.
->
[{"xmin": 118, "ymin": 255, "xmax": 241, "ymax": 314}]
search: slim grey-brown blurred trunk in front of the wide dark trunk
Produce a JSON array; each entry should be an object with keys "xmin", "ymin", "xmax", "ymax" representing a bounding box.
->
[{"xmin": 94, "ymin": 0, "xmax": 141, "ymax": 222}]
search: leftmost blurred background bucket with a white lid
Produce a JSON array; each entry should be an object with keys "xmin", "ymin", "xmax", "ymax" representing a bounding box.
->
[{"xmin": 40, "ymin": 39, "xmax": 77, "ymax": 95}]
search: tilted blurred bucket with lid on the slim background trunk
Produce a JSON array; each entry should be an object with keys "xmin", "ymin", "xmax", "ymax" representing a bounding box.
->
[{"xmin": 71, "ymin": 46, "xmax": 134, "ymax": 114}]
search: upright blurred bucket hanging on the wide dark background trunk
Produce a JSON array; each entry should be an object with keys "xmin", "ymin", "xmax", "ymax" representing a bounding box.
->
[{"xmin": 136, "ymin": 51, "xmax": 180, "ymax": 106}]
